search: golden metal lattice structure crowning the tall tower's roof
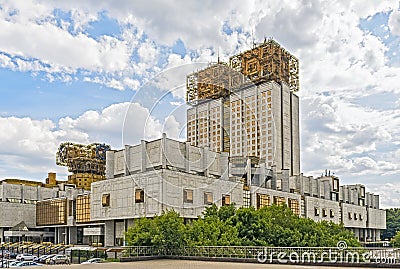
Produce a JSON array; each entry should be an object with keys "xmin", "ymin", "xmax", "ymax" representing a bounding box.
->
[{"xmin": 186, "ymin": 39, "xmax": 299, "ymax": 105}]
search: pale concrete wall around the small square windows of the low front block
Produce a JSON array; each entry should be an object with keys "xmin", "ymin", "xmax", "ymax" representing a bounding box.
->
[{"xmin": 91, "ymin": 170, "xmax": 243, "ymax": 221}]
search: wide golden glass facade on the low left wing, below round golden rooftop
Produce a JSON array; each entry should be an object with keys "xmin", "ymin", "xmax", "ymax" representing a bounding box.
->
[{"xmin": 36, "ymin": 199, "xmax": 67, "ymax": 226}]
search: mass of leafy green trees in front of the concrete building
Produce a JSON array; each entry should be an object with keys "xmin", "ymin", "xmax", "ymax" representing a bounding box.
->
[{"xmin": 126, "ymin": 205, "xmax": 360, "ymax": 247}]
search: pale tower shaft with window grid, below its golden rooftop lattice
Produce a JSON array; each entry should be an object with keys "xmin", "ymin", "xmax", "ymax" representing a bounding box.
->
[{"xmin": 187, "ymin": 81, "xmax": 300, "ymax": 175}]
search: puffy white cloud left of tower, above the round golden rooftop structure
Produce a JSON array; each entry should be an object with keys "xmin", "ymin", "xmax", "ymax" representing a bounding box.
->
[{"xmin": 0, "ymin": 103, "xmax": 180, "ymax": 178}]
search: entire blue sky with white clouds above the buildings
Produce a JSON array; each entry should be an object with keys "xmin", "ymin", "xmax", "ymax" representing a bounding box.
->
[{"xmin": 0, "ymin": 0, "xmax": 400, "ymax": 207}]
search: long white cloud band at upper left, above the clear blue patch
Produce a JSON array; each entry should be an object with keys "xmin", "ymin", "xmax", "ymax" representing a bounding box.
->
[{"xmin": 0, "ymin": 21, "xmax": 128, "ymax": 71}]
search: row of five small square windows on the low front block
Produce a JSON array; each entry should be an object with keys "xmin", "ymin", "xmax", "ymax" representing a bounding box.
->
[{"xmin": 101, "ymin": 189, "xmax": 231, "ymax": 207}]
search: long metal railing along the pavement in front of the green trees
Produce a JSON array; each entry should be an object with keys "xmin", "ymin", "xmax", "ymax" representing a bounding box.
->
[{"xmin": 123, "ymin": 246, "xmax": 400, "ymax": 266}]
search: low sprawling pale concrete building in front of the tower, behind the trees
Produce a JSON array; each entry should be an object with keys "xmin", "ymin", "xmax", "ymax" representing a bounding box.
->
[{"xmin": 39, "ymin": 135, "xmax": 378, "ymax": 246}]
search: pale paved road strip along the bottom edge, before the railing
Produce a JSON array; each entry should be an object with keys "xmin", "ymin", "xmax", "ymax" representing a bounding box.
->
[{"xmin": 40, "ymin": 260, "xmax": 396, "ymax": 269}]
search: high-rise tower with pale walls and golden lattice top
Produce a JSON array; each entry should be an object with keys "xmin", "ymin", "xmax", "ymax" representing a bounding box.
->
[{"xmin": 187, "ymin": 40, "xmax": 300, "ymax": 175}]
